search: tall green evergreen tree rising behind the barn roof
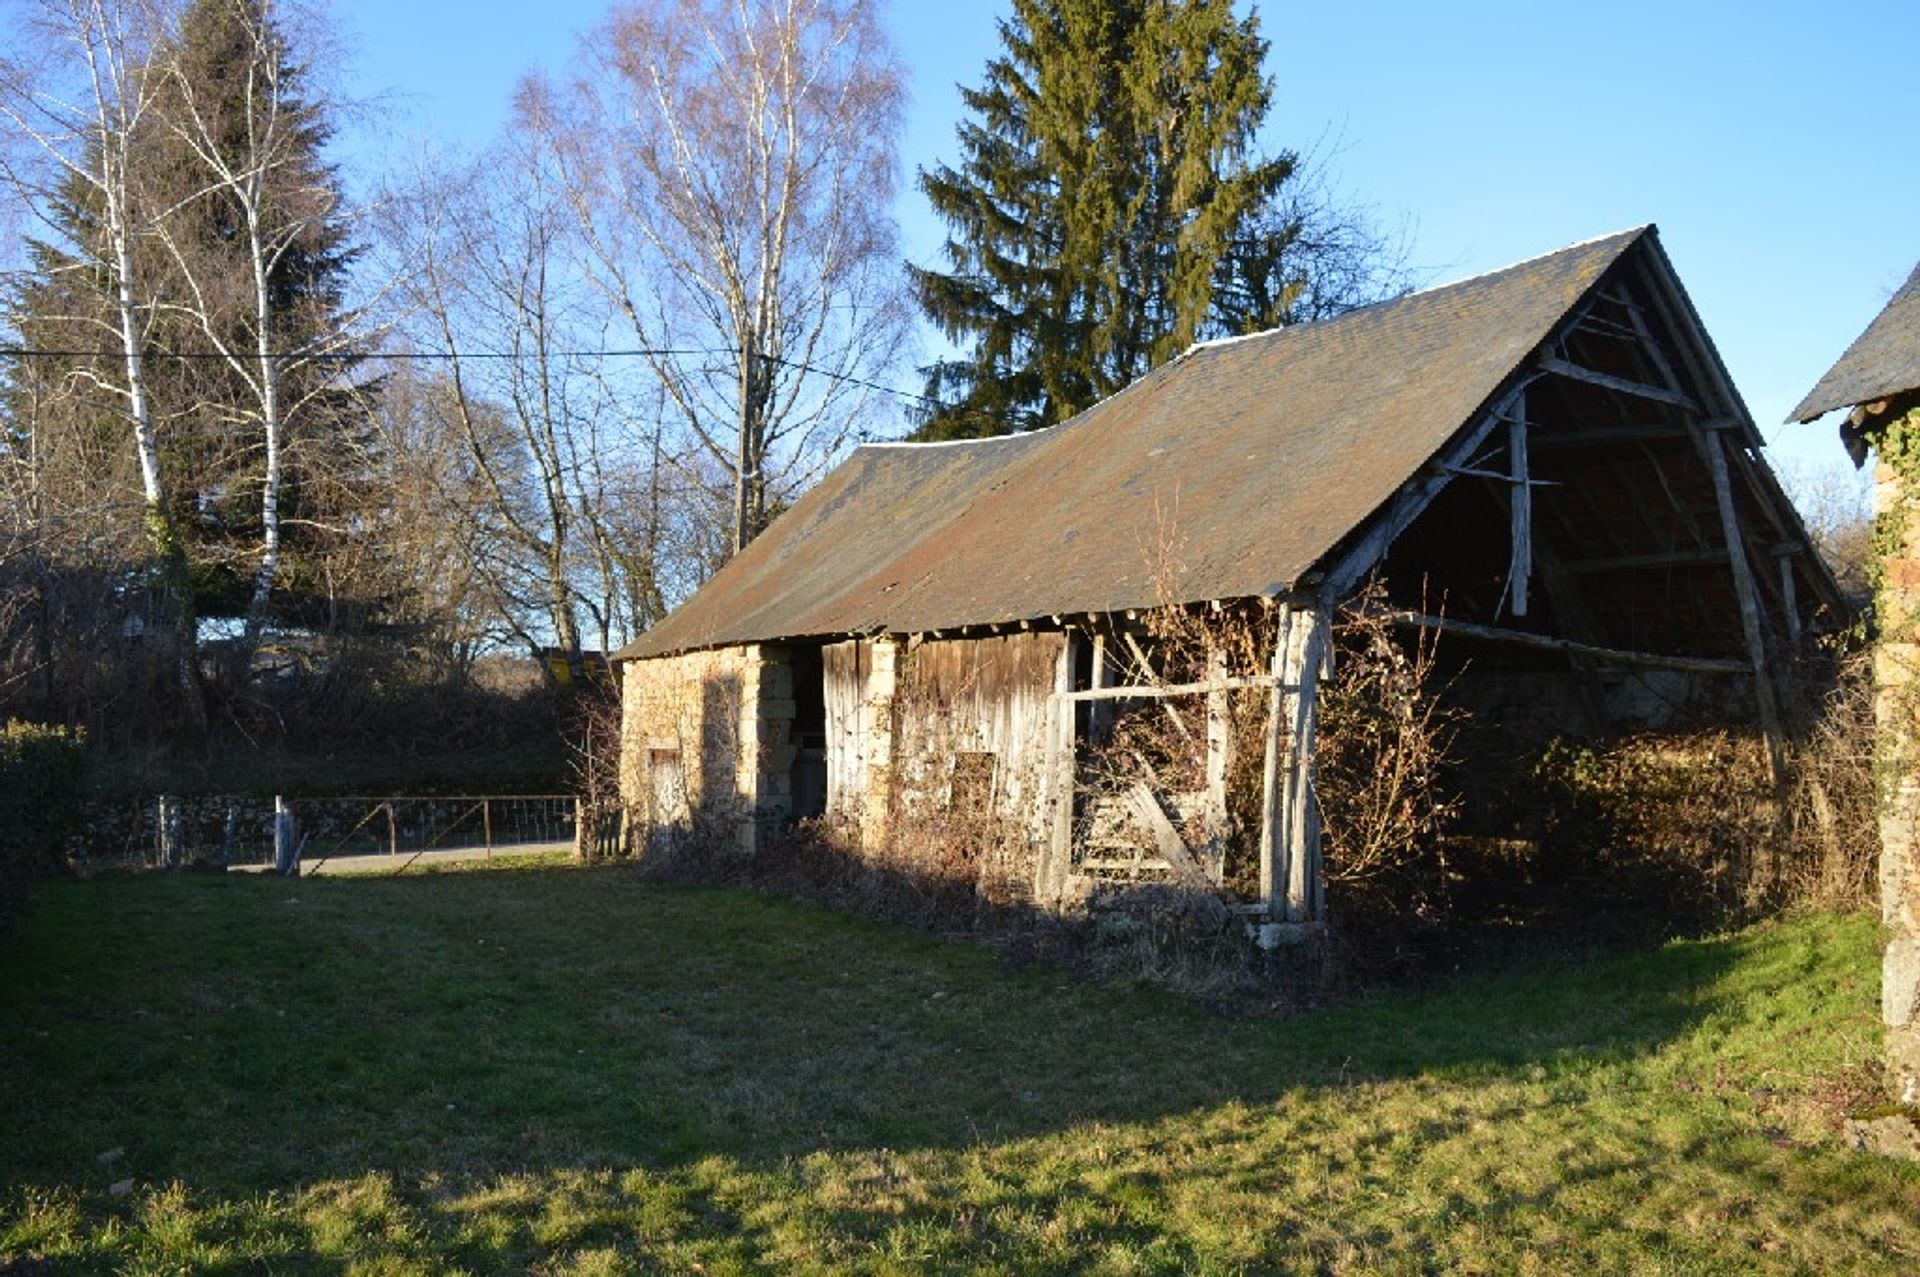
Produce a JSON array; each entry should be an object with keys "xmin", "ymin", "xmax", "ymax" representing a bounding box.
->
[{"xmin": 912, "ymin": 0, "xmax": 1294, "ymax": 438}]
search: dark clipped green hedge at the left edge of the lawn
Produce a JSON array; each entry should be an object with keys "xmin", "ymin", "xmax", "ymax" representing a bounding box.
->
[{"xmin": 0, "ymin": 720, "xmax": 86, "ymax": 933}]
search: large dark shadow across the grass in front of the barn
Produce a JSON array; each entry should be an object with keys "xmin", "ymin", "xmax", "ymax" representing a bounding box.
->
[{"xmin": 0, "ymin": 868, "xmax": 1740, "ymax": 1189}]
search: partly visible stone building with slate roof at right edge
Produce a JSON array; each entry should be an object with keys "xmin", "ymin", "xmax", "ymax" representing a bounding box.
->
[{"xmin": 1789, "ymin": 265, "xmax": 1920, "ymax": 1106}]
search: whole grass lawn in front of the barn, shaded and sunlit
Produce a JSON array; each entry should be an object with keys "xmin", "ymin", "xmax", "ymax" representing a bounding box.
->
[{"xmin": 0, "ymin": 866, "xmax": 1920, "ymax": 1273}]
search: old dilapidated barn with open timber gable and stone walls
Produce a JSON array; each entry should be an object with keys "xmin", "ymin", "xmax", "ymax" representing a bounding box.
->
[{"xmin": 616, "ymin": 227, "xmax": 1841, "ymax": 943}]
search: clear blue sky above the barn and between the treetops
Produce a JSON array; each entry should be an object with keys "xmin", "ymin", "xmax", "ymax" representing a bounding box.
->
[{"xmin": 332, "ymin": 0, "xmax": 1920, "ymax": 487}]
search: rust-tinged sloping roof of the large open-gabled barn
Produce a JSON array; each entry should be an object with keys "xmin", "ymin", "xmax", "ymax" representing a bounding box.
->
[{"xmin": 618, "ymin": 227, "xmax": 1653, "ymax": 659}]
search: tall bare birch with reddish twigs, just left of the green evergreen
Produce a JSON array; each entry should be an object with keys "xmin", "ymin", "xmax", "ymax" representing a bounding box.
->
[{"xmin": 549, "ymin": 0, "xmax": 906, "ymax": 553}]
